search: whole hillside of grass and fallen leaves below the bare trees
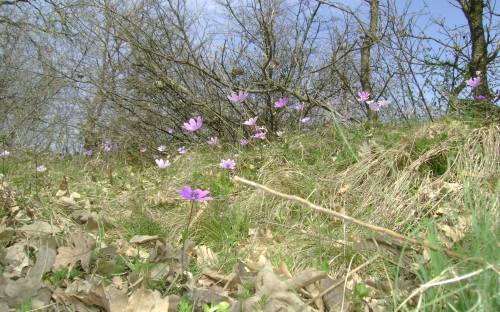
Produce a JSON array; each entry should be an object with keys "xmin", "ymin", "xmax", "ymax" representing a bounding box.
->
[{"xmin": 0, "ymin": 119, "xmax": 500, "ymax": 311}]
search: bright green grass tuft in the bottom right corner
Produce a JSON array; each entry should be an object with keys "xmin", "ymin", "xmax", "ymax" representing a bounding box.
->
[{"xmin": 404, "ymin": 185, "xmax": 500, "ymax": 311}]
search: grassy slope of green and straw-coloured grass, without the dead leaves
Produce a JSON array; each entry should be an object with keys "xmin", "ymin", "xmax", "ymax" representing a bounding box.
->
[{"xmin": 1, "ymin": 120, "xmax": 500, "ymax": 311}]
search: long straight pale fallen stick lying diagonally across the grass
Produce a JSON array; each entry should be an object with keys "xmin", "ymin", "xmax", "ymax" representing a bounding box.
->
[{"xmin": 233, "ymin": 176, "xmax": 463, "ymax": 258}]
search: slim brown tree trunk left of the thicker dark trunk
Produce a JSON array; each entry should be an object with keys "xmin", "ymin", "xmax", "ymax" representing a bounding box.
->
[{"xmin": 360, "ymin": 0, "xmax": 378, "ymax": 121}]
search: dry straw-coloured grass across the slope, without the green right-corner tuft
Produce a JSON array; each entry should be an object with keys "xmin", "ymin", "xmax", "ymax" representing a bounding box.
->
[{"xmin": 1, "ymin": 121, "xmax": 500, "ymax": 271}]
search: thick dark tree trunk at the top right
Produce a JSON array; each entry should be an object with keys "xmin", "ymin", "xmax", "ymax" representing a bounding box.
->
[{"xmin": 460, "ymin": 0, "xmax": 491, "ymax": 97}]
